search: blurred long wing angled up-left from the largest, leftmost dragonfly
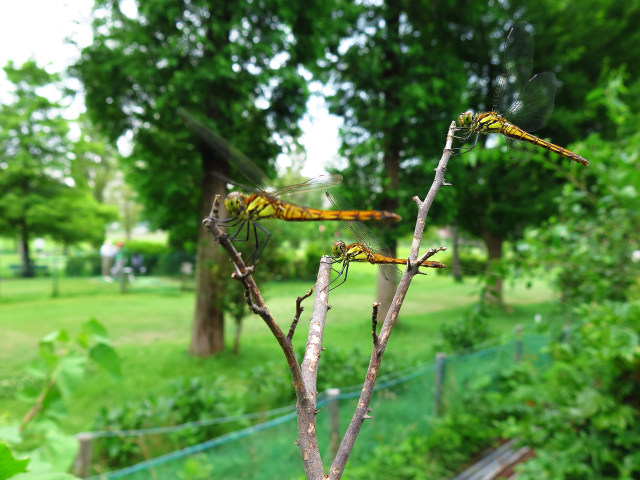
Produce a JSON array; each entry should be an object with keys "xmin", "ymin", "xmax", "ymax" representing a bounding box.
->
[{"xmin": 177, "ymin": 108, "xmax": 269, "ymax": 190}]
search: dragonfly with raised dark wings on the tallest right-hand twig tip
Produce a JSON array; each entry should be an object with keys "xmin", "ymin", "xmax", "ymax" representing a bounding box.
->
[{"xmin": 458, "ymin": 22, "xmax": 589, "ymax": 166}]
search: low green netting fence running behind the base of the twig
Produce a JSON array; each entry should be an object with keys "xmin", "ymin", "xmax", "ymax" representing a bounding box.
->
[{"xmin": 84, "ymin": 333, "xmax": 550, "ymax": 480}]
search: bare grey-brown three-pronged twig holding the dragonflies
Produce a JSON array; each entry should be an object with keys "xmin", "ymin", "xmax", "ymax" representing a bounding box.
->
[{"xmin": 203, "ymin": 122, "xmax": 456, "ymax": 480}]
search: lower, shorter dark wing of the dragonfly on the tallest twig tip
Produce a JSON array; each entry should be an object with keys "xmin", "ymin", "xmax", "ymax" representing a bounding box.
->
[{"xmin": 504, "ymin": 72, "xmax": 558, "ymax": 132}]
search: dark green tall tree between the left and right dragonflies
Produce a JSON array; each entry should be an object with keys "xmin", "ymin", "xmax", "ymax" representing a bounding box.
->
[{"xmin": 316, "ymin": 0, "xmax": 476, "ymax": 315}]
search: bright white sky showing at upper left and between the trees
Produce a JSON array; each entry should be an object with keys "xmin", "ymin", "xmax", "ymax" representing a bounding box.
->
[{"xmin": 0, "ymin": 0, "xmax": 340, "ymax": 176}]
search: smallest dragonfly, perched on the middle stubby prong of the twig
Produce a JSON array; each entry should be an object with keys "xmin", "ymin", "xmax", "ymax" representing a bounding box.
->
[{"xmin": 326, "ymin": 191, "xmax": 447, "ymax": 290}]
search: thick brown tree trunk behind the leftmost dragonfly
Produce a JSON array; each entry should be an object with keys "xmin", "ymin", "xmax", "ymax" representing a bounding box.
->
[{"xmin": 190, "ymin": 154, "xmax": 231, "ymax": 357}]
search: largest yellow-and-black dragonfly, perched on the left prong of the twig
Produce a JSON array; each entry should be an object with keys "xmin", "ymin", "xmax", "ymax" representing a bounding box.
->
[{"xmin": 178, "ymin": 109, "xmax": 402, "ymax": 264}]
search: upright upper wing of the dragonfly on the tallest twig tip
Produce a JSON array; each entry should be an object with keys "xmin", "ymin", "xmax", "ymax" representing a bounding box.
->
[{"xmin": 493, "ymin": 22, "xmax": 533, "ymax": 114}]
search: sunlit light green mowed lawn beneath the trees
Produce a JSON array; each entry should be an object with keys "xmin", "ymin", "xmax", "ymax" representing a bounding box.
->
[{"xmin": 0, "ymin": 265, "xmax": 555, "ymax": 432}]
